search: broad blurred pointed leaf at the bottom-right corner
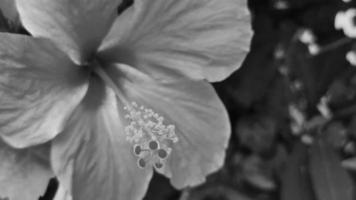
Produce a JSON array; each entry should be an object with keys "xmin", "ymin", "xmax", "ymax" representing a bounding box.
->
[{"xmin": 309, "ymin": 139, "xmax": 353, "ymax": 200}]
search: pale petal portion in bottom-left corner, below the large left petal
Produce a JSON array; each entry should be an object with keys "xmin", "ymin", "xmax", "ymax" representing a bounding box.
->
[{"xmin": 0, "ymin": 139, "xmax": 54, "ymax": 200}]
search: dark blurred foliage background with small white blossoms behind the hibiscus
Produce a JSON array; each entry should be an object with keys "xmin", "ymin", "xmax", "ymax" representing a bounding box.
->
[{"xmin": 0, "ymin": 0, "xmax": 356, "ymax": 200}]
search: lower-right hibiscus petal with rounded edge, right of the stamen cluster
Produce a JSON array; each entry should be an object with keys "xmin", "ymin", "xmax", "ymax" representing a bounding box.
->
[{"xmin": 106, "ymin": 65, "xmax": 231, "ymax": 188}]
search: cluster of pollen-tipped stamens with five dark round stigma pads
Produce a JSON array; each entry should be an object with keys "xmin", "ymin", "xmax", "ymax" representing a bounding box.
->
[{"xmin": 124, "ymin": 102, "xmax": 178, "ymax": 170}]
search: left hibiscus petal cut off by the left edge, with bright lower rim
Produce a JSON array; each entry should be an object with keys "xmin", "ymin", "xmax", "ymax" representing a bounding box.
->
[{"xmin": 0, "ymin": 33, "xmax": 87, "ymax": 148}]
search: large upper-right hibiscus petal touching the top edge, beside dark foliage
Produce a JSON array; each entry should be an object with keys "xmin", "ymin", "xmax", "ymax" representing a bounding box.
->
[{"xmin": 100, "ymin": 0, "xmax": 251, "ymax": 81}]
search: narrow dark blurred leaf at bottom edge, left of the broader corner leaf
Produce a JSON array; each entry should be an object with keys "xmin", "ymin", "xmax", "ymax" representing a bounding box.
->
[{"xmin": 280, "ymin": 143, "xmax": 315, "ymax": 200}]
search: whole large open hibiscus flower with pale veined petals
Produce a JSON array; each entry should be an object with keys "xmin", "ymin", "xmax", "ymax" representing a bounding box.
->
[{"xmin": 0, "ymin": 0, "xmax": 251, "ymax": 200}]
